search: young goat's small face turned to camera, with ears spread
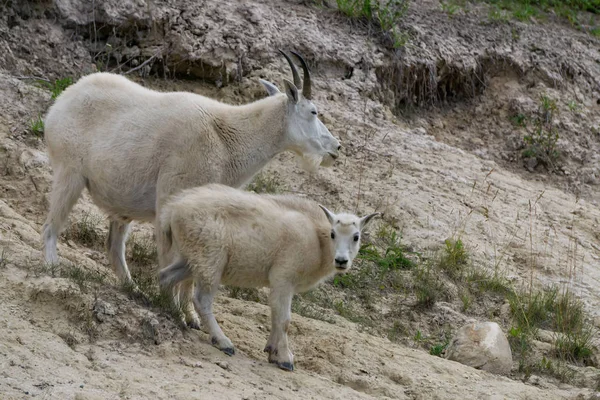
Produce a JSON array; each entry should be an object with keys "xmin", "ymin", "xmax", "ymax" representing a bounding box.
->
[{"xmin": 319, "ymin": 204, "xmax": 381, "ymax": 272}]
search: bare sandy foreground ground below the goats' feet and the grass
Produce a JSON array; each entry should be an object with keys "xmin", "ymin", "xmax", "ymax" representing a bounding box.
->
[{"xmin": 0, "ymin": 209, "xmax": 587, "ymax": 399}]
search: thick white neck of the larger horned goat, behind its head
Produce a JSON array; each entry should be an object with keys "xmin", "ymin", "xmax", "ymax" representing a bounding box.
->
[{"xmin": 221, "ymin": 95, "xmax": 287, "ymax": 187}]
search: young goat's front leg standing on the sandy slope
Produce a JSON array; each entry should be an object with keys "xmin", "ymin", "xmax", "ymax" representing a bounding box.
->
[{"xmin": 265, "ymin": 287, "xmax": 294, "ymax": 371}]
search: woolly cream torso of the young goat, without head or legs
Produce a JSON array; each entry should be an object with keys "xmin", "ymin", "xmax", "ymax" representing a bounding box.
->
[{"xmin": 161, "ymin": 184, "xmax": 331, "ymax": 287}]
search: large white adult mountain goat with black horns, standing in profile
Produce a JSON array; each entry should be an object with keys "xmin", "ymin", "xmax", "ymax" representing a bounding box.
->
[{"xmin": 42, "ymin": 52, "xmax": 340, "ymax": 328}]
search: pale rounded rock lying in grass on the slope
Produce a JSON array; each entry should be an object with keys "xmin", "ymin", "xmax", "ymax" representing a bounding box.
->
[{"xmin": 446, "ymin": 322, "xmax": 512, "ymax": 375}]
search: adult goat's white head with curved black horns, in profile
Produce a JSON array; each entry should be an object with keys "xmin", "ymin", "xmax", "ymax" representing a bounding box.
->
[{"xmin": 260, "ymin": 50, "xmax": 341, "ymax": 171}]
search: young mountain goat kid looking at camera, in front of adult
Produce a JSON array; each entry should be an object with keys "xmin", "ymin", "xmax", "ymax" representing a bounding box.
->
[{"xmin": 159, "ymin": 184, "xmax": 379, "ymax": 370}]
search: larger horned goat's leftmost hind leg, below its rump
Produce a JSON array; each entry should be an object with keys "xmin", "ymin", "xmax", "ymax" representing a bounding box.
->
[{"xmin": 42, "ymin": 167, "xmax": 85, "ymax": 264}]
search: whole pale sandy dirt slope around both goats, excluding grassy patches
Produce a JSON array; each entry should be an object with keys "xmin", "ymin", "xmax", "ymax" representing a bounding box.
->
[{"xmin": 0, "ymin": 0, "xmax": 600, "ymax": 399}]
